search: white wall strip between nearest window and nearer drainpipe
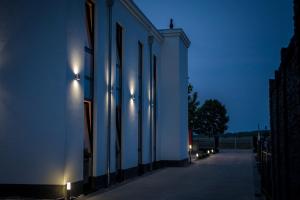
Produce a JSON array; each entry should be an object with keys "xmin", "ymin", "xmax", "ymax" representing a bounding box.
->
[{"xmin": 93, "ymin": 0, "xmax": 108, "ymax": 176}]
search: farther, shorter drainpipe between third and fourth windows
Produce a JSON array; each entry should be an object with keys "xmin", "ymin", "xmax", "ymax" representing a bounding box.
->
[{"xmin": 148, "ymin": 36, "xmax": 153, "ymax": 171}]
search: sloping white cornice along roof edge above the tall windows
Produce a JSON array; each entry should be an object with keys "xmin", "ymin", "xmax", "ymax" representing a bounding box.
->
[{"xmin": 120, "ymin": 0, "xmax": 164, "ymax": 43}]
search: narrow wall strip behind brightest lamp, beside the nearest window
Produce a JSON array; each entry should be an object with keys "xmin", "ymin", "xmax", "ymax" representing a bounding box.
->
[{"xmin": 62, "ymin": 0, "xmax": 87, "ymax": 184}]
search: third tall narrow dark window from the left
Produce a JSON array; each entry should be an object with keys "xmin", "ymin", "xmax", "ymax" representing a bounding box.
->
[{"xmin": 138, "ymin": 42, "xmax": 143, "ymax": 174}]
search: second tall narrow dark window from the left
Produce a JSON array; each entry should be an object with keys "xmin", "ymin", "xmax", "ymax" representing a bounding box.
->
[{"xmin": 116, "ymin": 24, "xmax": 123, "ymax": 181}]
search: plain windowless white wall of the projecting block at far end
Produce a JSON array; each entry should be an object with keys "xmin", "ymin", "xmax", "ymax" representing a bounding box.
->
[{"xmin": 158, "ymin": 30, "xmax": 188, "ymax": 160}]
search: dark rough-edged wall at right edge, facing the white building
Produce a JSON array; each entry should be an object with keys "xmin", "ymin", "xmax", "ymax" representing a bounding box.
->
[{"xmin": 269, "ymin": 0, "xmax": 300, "ymax": 197}]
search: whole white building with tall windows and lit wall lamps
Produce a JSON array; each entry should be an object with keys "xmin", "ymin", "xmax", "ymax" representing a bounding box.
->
[{"xmin": 0, "ymin": 0, "xmax": 190, "ymax": 198}]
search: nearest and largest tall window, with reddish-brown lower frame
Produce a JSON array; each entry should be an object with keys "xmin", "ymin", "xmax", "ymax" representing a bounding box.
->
[{"xmin": 83, "ymin": 0, "xmax": 94, "ymax": 190}]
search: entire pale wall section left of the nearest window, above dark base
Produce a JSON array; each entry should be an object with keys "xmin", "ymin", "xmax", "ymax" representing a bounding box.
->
[{"xmin": 0, "ymin": 0, "xmax": 84, "ymax": 185}]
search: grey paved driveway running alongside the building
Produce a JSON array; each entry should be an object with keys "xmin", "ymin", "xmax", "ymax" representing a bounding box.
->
[{"xmin": 88, "ymin": 150, "xmax": 255, "ymax": 200}]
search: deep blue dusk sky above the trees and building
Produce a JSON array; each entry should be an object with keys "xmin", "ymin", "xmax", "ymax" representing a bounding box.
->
[{"xmin": 135, "ymin": 0, "xmax": 293, "ymax": 131}]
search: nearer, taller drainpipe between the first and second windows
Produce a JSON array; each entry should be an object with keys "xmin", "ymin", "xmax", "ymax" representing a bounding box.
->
[{"xmin": 106, "ymin": 0, "xmax": 114, "ymax": 187}]
